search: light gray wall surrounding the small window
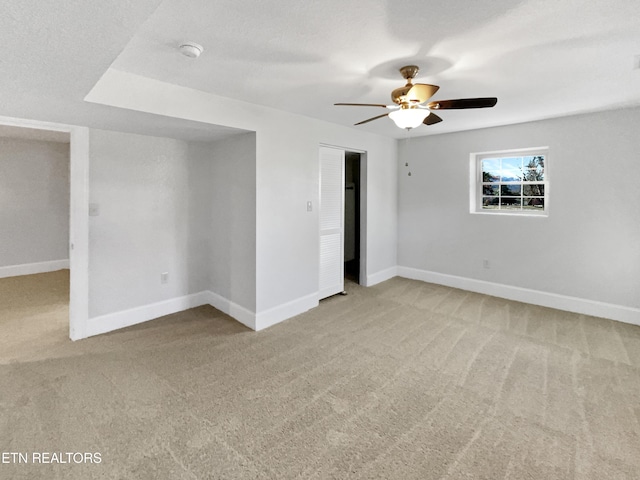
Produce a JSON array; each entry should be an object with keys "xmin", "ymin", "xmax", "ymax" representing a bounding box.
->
[{"xmin": 398, "ymin": 109, "xmax": 640, "ymax": 314}]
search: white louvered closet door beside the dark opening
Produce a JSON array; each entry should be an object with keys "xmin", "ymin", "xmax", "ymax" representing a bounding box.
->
[{"xmin": 320, "ymin": 147, "xmax": 344, "ymax": 299}]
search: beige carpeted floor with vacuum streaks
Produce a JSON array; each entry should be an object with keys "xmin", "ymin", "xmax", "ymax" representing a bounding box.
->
[{"xmin": 0, "ymin": 272, "xmax": 640, "ymax": 480}]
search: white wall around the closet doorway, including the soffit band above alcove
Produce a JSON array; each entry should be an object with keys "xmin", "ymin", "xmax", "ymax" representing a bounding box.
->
[{"xmin": 86, "ymin": 69, "xmax": 398, "ymax": 328}]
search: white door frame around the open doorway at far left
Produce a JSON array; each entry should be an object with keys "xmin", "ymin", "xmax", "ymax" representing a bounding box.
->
[{"xmin": 0, "ymin": 116, "xmax": 89, "ymax": 340}]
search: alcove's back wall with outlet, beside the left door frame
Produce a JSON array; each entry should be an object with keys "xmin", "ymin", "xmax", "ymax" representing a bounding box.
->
[{"xmin": 89, "ymin": 130, "xmax": 208, "ymax": 318}]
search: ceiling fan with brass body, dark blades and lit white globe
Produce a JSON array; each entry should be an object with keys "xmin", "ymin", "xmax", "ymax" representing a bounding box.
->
[{"xmin": 334, "ymin": 65, "xmax": 498, "ymax": 130}]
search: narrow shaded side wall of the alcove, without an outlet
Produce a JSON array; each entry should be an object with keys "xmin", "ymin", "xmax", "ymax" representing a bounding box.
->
[{"xmin": 189, "ymin": 133, "xmax": 256, "ymax": 313}]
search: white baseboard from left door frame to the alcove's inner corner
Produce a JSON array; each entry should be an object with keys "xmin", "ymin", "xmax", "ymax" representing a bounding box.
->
[{"xmin": 87, "ymin": 292, "xmax": 210, "ymax": 337}]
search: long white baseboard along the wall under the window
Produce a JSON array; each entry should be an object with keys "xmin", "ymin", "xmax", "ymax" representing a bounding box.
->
[{"xmin": 398, "ymin": 266, "xmax": 640, "ymax": 325}]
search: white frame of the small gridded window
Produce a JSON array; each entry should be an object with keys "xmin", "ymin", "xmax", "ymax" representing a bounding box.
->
[{"xmin": 469, "ymin": 147, "xmax": 549, "ymax": 217}]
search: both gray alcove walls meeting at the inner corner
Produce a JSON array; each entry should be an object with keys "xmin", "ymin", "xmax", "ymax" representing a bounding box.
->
[{"xmin": 89, "ymin": 130, "xmax": 256, "ymax": 318}]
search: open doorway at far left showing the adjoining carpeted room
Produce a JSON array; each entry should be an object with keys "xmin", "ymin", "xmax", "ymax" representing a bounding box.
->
[{"xmin": 0, "ymin": 124, "xmax": 71, "ymax": 361}]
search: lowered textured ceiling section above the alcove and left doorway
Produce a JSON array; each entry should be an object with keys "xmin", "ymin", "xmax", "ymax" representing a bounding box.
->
[{"xmin": 0, "ymin": 0, "xmax": 248, "ymax": 141}]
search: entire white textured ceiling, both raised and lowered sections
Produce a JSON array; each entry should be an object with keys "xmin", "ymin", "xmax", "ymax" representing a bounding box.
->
[{"xmin": 0, "ymin": 0, "xmax": 640, "ymax": 139}]
